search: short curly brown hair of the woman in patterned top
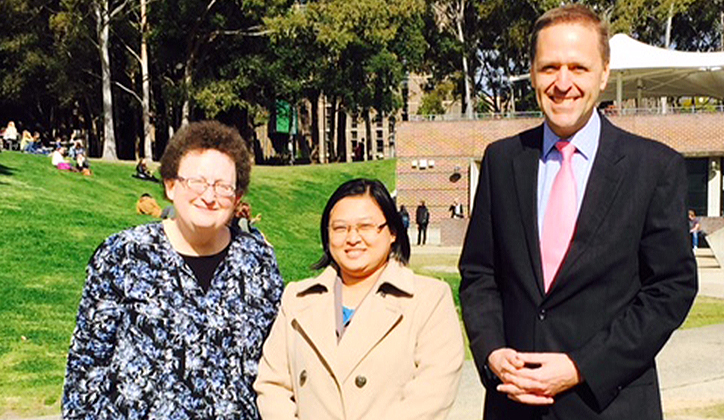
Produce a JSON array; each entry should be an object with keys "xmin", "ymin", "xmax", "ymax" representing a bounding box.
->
[{"xmin": 159, "ymin": 121, "xmax": 251, "ymax": 194}]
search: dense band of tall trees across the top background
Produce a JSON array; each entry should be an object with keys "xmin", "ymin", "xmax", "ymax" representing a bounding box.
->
[{"xmin": 0, "ymin": 0, "xmax": 724, "ymax": 160}]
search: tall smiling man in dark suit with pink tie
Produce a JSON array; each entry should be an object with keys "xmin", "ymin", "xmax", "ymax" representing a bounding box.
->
[{"xmin": 460, "ymin": 5, "xmax": 697, "ymax": 420}]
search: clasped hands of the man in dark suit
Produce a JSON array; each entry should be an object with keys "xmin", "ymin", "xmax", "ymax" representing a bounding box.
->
[{"xmin": 488, "ymin": 348, "xmax": 582, "ymax": 405}]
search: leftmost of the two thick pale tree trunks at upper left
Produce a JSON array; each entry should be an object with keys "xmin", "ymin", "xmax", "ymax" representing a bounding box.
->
[{"xmin": 95, "ymin": 0, "xmax": 118, "ymax": 160}]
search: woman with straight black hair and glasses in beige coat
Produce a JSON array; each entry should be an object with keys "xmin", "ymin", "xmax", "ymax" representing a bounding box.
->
[{"xmin": 254, "ymin": 179, "xmax": 464, "ymax": 420}]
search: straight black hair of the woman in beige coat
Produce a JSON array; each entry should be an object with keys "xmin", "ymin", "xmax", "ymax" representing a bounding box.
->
[{"xmin": 312, "ymin": 178, "xmax": 410, "ymax": 270}]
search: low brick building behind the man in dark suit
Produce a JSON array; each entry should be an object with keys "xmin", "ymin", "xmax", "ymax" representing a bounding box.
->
[{"xmin": 396, "ymin": 110, "xmax": 724, "ymax": 244}]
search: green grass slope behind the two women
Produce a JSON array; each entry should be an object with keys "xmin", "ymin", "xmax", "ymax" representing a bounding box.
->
[{"xmin": 0, "ymin": 152, "xmax": 395, "ymax": 417}]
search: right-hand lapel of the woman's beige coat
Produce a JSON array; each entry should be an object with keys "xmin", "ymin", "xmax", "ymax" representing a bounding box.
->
[{"xmin": 337, "ymin": 261, "xmax": 413, "ymax": 382}]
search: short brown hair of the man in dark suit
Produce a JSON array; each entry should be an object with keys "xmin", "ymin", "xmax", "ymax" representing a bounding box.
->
[{"xmin": 530, "ymin": 4, "xmax": 611, "ymax": 64}]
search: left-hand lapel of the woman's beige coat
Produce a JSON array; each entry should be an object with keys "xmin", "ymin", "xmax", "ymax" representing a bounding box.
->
[{"xmin": 293, "ymin": 267, "xmax": 337, "ymax": 375}]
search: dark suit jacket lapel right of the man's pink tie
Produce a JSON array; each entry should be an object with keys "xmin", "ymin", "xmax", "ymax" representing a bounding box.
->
[{"xmin": 548, "ymin": 117, "xmax": 625, "ymax": 300}]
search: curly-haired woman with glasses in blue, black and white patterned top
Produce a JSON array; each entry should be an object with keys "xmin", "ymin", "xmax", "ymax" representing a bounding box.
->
[{"xmin": 62, "ymin": 121, "xmax": 283, "ymax": 419}]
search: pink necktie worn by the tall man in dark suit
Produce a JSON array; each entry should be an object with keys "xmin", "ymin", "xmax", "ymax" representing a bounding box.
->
[{"xmin": 541, "ymin": 141, "xmax": 578, "ymax": 293}]
